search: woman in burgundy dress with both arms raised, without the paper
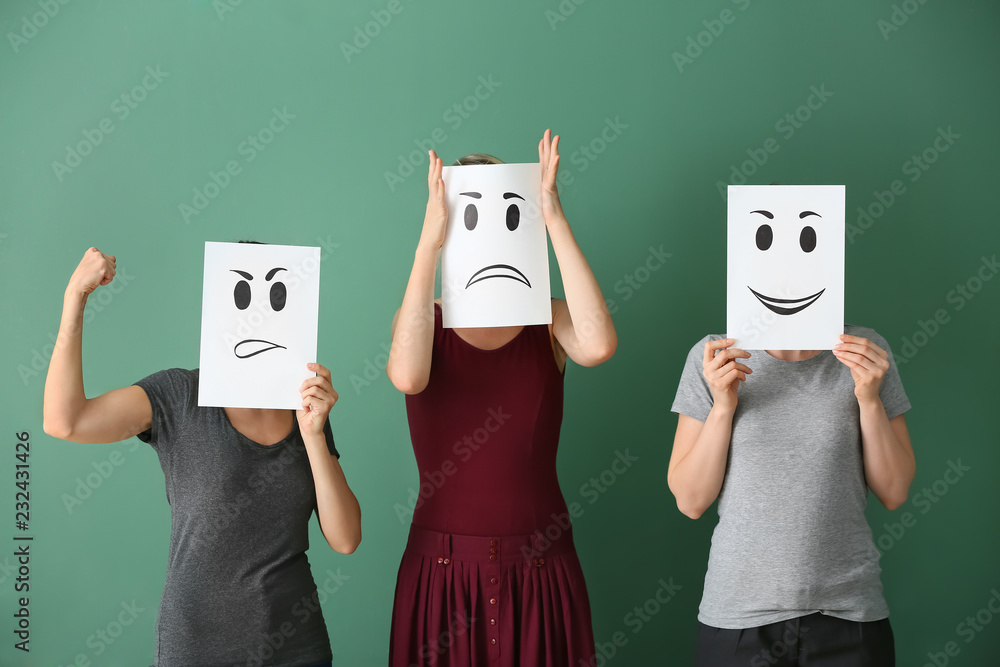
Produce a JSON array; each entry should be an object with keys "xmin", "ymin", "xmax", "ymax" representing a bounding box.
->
[{"xmin": 386, "ymin": 130, "xmax": 617, "ymax": 667}]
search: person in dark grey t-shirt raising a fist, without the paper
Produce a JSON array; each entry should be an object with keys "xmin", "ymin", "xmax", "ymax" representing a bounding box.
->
[{"xmin": 44, "ymin": 248, "xmax": 361, "ymax": 667}]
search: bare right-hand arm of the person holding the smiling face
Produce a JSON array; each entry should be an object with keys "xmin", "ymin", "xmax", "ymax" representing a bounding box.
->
[{"xmin": 834, "ymin": 334, "xmax": 917, "ymax": 510}]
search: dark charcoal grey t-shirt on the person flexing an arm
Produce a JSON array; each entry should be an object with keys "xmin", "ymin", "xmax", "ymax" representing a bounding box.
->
[{"xmin": 136, "ymin": 368, "xmax": 339, "ymax": 667}]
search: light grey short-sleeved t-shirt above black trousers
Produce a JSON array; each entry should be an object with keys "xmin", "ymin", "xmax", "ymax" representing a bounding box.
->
[{"xmin": 671, "ymin": 325, "xmax": 910, "ymax": 628}]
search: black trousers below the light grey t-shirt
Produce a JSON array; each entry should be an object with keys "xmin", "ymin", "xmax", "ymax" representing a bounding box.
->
[{"xmin": 695, "ymin": 613, "xmax": 896, "ymax": 667}]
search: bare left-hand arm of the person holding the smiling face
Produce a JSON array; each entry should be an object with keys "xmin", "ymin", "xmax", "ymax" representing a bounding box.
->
[{"xmin": 667, "ymin": 338, "xmax": 753, "ymax": 519}]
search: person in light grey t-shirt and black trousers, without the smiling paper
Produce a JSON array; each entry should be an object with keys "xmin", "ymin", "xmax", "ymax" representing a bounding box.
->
[{"xmin": 667, "ymin": 325, "xmax": 915, "ymax": 667}]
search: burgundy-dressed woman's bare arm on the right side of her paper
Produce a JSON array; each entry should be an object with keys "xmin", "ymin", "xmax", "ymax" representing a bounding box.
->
[{"xmin": 538, "ymin": 130, "xmax": 618, "ymax": 366}]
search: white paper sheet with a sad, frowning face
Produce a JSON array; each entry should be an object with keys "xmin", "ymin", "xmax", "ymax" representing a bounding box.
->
[{"xmin": 441, "ymin": 163, "xmax": 552, "ymax": 328}]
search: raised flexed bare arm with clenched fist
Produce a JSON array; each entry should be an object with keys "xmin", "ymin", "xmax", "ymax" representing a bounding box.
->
[{"xmin": 42, "ymin": 248, "xmax": 153, "ymax": 443}]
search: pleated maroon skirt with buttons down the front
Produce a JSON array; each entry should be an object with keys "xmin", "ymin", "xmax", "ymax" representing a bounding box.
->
[{"xmin": 389, "ymin": 526, "xmax": 594, "ymax": 667}]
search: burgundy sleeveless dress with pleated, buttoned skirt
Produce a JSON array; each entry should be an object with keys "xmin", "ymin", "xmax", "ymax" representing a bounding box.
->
[{"xmin": 389, "ymin": 305, "xmax": 594, "ymax": 667}]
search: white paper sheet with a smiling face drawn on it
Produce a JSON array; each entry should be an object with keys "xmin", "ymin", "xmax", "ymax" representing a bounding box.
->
[{"xmin": 726, "ymin": 185, "xmax": 845, "ymax": 350}]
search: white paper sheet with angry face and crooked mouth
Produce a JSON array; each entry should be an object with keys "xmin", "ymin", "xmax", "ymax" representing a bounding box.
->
[{"xmin": 198, "ymin": 242, "xmax": 320, "ymax": 409}]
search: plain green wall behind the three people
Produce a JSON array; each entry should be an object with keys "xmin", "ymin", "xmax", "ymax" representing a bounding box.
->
[{"xmin": 0, "ymin": 0, "xmax": 1000, "ymax": 667}]
